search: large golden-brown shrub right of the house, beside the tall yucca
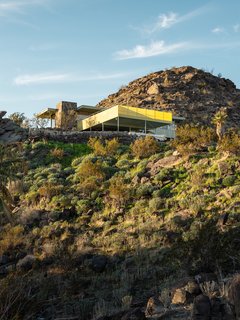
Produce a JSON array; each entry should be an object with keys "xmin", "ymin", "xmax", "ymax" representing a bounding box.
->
[{"xmin": 172, "ymin": 124, "xmax": 216, "ymax": 156}]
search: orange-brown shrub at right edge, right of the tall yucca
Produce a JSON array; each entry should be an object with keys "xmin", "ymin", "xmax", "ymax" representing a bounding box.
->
[{"xmin": 217, "ymin": 132, "xmax": 240, "ymax": 155}]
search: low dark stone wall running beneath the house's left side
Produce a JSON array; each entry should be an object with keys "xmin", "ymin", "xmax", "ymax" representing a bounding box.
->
[{"xmin": 29, "ymin": 129, "xmax": 138, "ymax": 144}]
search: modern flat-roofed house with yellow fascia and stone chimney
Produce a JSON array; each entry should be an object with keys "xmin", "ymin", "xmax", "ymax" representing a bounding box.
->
[{"xmin": 37, "ymin": 101, "xmax": 183, "ymax": 138}]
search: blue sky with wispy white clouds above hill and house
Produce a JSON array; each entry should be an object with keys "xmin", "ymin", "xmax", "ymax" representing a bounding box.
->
[{"xmin": 0, "ymin": 0, "xmax": 240, "ymax": 117}]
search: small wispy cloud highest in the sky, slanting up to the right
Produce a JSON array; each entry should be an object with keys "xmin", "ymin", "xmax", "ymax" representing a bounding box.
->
[{"xmin": 142, "ymin": 7, "xmax": 206, "ymax": 34}]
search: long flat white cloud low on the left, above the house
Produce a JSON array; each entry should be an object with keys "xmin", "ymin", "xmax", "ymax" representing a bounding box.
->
[{"xmin": 13, "ymin": 73, "xmax": 129, "ymax": 86}]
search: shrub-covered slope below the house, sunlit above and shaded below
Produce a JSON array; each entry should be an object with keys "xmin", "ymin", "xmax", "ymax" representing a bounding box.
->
[{"xmin": 0, "ymin": 134, "xmax": 240, "ymax": 320}]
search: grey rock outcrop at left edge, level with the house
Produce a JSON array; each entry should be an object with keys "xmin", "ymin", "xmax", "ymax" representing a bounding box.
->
[{"xmin": 0, "ymin": 111, "xmax": 27, "ymax": 143}]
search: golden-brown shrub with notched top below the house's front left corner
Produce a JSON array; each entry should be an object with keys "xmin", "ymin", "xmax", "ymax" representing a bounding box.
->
[{"xmin": 88, "ymin": 137, "xmax": 120, "ymax": 156}]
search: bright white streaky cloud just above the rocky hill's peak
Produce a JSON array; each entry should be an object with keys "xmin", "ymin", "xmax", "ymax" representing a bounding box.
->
[{"xmin": 115, "ymin": 40, "xmax": 187, "ymax": 60}]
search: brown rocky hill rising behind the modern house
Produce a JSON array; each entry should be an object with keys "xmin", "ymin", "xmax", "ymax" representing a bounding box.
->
[{"xmin": 97, "ymin": 66, "xmax": 240, "ymax": 126}]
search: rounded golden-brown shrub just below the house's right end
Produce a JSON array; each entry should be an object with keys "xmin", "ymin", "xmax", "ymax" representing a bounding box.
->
[{"xmin": 130, "ymin": 136, "xmax": 159, "ymax": 159}]
